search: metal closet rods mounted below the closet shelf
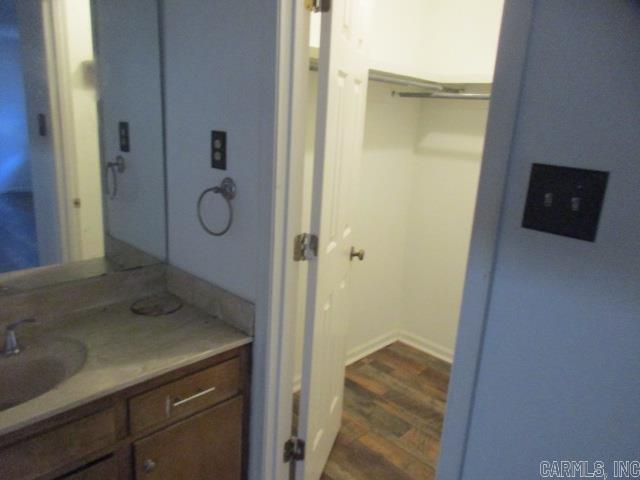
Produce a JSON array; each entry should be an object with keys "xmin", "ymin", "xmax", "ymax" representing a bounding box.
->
[{"xmin": 309, "ymin": 58, "xmax": 491, "ymax": 100}]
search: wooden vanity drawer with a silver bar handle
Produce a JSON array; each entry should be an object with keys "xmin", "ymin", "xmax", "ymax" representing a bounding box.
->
[{"xmin": 129, "ymin": 357, "xmax": 242, "ymax": 433}]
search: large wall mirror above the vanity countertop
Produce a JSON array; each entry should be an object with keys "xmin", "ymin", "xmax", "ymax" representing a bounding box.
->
[{"xmin": 0, "ymin": 0, "xmax": 167, "ymax": 286}]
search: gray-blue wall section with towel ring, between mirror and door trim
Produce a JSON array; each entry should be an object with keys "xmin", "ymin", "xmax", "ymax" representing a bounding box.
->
[{"xmin": 164, "ymin": 0, "xmax": 276, "ymax": 301}]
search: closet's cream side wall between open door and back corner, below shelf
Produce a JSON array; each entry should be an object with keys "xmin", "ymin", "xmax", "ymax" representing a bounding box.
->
[{"xmin": 347, "ymin": 82, "xmax": 420, "ymax": 358}]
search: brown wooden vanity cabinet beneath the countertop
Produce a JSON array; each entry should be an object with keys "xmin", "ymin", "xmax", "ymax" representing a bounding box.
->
[{"xmin": 0, "ymin": 346, "xmax": 250, "ymax": 480}]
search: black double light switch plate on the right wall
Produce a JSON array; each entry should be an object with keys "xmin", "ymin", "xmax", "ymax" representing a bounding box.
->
[{"xmin": 522, "ymin": 163, "xmax": 609, "ymax": 242}]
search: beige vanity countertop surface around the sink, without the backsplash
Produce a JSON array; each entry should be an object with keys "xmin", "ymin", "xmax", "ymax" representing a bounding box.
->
[{"xmin": 0, "ymin": 302, "xmax": 252, "ymax": 436}]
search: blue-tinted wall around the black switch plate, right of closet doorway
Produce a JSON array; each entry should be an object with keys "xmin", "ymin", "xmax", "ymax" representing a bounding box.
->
[{"xmin": 452, "ymin": 0, "xmax": 640, "ymax": 479}]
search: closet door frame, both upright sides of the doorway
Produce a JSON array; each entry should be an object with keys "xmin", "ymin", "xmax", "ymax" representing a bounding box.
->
[{"xmin": 260, "ymin": 0, "xmax": 535, "ymax": 480}]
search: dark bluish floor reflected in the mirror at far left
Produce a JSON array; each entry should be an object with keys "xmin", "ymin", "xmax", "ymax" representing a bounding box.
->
[{"xmin": 0, "ymin": 192, "xmax": 38, "ymax": 273}]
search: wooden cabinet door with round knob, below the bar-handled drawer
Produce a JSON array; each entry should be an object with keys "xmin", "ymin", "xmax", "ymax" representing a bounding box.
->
[{"xmin": 134, "ymin": 397, "xmax": 243, "ymax": 480}]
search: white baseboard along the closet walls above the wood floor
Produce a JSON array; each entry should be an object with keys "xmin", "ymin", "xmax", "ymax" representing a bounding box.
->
[{"xmin": 293, "ymin": 330, "xmax": 453, "ymax": 392}]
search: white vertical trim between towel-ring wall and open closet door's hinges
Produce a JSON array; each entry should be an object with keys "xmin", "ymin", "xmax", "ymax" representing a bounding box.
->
[{"xmin": 249, "ymin": 0, "xmax": 309, "ymax": 480}]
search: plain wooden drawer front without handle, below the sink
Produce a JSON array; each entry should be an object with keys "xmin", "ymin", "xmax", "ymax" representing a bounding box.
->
[{"xmin": 0, "ymin": 409, "xmax": 116, "ymax": 480}]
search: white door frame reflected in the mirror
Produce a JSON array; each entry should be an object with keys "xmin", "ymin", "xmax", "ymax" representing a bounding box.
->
[{"xmin": 42, "ymin": 0, "xmax": 104, "ymax": 263}]
